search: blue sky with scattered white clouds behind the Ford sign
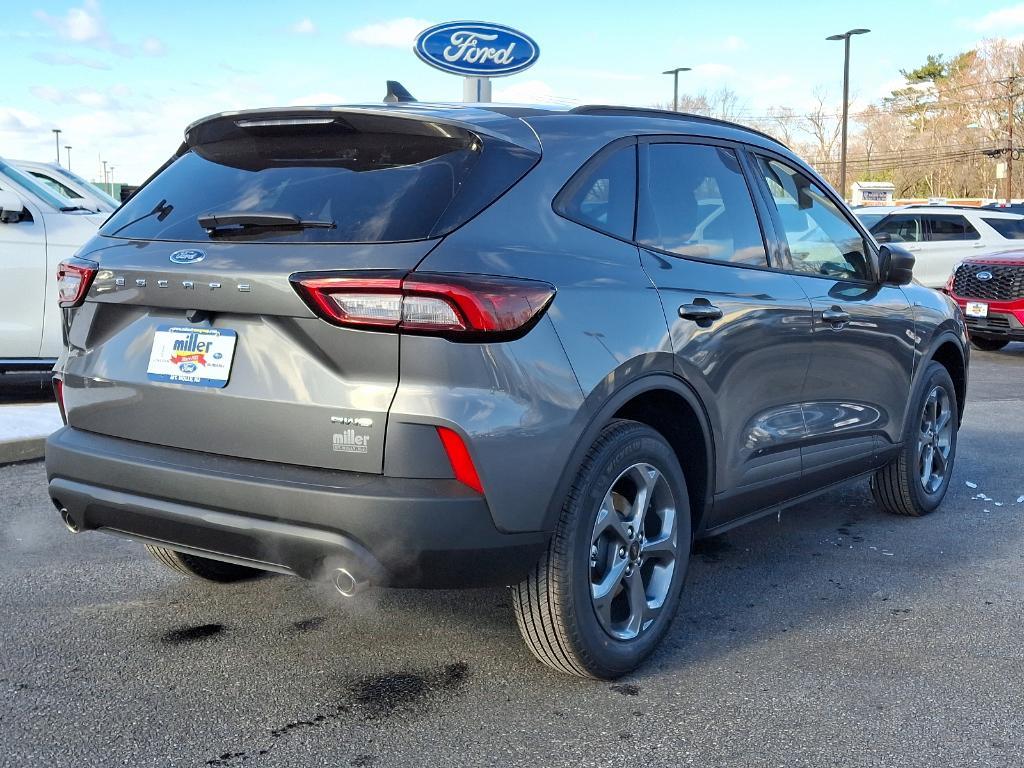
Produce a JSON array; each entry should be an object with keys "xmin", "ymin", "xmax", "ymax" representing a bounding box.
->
[{"xmin": 6, "ymin": 0, "xmax": 1024, "ymax": 183}]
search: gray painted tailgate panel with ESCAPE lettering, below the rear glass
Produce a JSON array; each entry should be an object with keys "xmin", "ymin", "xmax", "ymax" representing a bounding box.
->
[{"xmin": 65, "ymin": 241, "xmax": 434, "ymax": 472}]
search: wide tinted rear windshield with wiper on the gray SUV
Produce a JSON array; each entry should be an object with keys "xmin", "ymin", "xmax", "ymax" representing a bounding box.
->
[{"xmin": 101, "ymin": 118, "xmax": 536, "ymax": 243}]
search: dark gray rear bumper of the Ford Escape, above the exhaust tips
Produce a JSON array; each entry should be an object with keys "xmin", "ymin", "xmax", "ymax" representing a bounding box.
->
[{"xmin": 46, "ymin": 427, "xmax": 548, "ymax": 587}]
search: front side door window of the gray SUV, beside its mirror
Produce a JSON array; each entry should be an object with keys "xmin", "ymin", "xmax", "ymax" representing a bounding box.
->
[{"xmin": 758, "ymin": 157, "xmax": 872, "ymax": 280}]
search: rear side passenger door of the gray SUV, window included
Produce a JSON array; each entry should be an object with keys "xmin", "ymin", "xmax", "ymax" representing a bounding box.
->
[{"xmin": 636, "ymin": 137, "xmax": 811, "ymax": 527}]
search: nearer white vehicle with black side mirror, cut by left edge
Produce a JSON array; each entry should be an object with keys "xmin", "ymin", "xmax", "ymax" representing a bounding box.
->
[{"xmin": 0, "ymin": 160, "xmax": 106, "ymax": 373}]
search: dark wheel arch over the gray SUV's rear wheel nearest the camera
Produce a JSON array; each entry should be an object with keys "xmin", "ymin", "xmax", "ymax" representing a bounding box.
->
[{"xmin": 545, "ymin": 374, "xmax": 715, "ymax": 535}]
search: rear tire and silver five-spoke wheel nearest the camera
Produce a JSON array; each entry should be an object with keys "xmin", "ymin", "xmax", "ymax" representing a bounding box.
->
[{"xmin": 512, "ymin": 421, "xmax": 691, "ymax": 680}]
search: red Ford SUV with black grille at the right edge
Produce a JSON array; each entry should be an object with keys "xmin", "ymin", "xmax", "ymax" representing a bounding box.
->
[{"xmin": 946, "ymin": 249, "xmax": 1024, "ymax": 352}]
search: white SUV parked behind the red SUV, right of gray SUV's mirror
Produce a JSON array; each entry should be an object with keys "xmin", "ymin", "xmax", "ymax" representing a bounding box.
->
[{"xmin": 870, "ymin": 206, "xmax": 1024, "ymax": 288}]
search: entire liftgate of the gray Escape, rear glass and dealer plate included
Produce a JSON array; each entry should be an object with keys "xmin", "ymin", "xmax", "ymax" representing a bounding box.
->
[{"xmin": 65, "ymin": 113, "xmax": 535, "ymax": 473}]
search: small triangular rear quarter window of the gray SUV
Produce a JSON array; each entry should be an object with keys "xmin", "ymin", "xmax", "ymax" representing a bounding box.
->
[{"xmin": 555, "ymin": 144, "xmax": 637, "ymax": 240}]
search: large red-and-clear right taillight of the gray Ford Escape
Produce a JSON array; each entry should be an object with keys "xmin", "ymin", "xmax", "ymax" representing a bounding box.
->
[{"xmin": 292, "ymin": 272, "xmax": 555, "ymax": 340}]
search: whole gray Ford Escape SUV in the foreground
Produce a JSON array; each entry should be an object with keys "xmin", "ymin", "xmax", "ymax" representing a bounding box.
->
[{"xmin": 46, "ymin": 103, "xmax": 968, "ymax": 678}]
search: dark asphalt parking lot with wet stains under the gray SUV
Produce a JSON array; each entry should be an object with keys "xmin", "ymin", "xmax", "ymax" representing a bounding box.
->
[{"xmin": 0, "ymin": 344, "xmax": 1024, "ymax": 768}]
